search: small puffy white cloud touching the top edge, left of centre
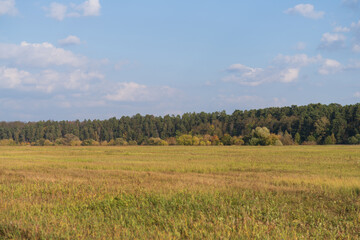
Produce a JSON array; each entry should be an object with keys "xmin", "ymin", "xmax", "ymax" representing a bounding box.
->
[{"xmin": 44, "ymin": 0, "xmax": 101, "ymax": 21}]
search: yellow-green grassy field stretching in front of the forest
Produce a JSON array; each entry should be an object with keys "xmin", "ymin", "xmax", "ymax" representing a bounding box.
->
[{"xmin": 0, "ymin": 146, "xmax": 360, "ymax": 239}]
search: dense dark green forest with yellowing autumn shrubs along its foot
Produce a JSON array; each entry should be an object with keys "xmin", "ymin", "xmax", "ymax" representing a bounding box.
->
[{"xmin": 0, "ymin": 104, "xmax": 360, "ymax": 145}]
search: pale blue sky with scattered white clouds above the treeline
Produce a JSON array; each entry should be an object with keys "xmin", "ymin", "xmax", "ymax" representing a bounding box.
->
[{"xmin": 0, "ymin": 0, "xmax": 360, "ymax": 122}]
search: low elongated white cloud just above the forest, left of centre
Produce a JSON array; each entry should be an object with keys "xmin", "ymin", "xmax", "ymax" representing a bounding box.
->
[{"xmin": 105, "ymin": 82, "xmax": 177, "ymax": 102}]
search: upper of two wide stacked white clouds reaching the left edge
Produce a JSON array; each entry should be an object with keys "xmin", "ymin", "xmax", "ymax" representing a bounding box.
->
[{"xmin": 0, "ymin": 42, "xmax": 88, "ymax": 67}]
